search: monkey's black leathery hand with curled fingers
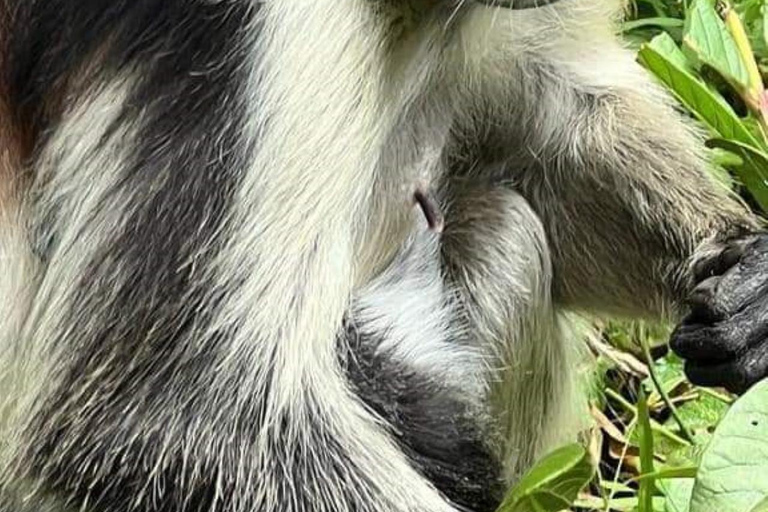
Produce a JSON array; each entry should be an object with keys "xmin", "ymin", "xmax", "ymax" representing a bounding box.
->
[{"xmin": 671, "ymin": 234, "xmax": 768, "ymax": 393}]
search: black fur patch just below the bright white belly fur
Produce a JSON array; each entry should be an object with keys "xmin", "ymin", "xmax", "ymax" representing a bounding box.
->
[{"xmin": 342, "ymin": 322, "xmax": 504, "ymax": 512}]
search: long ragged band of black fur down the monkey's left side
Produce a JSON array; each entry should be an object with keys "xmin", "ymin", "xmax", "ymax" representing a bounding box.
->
[{"xmin": 8, "ymin": 0, "xmax": 267, "ymax": 512}]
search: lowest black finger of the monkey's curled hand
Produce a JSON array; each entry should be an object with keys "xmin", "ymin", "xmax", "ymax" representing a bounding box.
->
[{"xmin": 685, "ymin": 343, "xmax": 768, "ymax": 394}]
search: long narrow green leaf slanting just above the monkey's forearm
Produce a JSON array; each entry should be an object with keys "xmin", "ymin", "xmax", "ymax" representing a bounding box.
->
[{"xmin": 638, "ymin": 34, "xmax": 760, "ymax": 147}]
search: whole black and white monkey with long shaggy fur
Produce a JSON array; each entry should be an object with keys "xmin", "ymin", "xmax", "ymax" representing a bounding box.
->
[{"xmin": 0, "ymin": 0, "xmax": 768, "ymax": 512}]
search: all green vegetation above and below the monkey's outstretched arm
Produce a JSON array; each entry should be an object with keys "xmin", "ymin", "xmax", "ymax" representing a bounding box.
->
[{"xmin": 499, "ymin": 0, "xmax": 768, "ymax": 512}]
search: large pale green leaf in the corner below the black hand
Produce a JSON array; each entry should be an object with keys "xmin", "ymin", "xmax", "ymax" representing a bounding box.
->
[{"xmin": 691, "ymin": 380, "xmax": 768, "ymax": 512}]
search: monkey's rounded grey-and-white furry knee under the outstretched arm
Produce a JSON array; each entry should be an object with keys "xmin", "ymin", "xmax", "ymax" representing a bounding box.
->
[{"xmin": 443, "ymin": 183, "xmax": 552, "ymax": 339}]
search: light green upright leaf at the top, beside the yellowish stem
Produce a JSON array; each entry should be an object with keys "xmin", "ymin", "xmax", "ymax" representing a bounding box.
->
[{"xmin": 683, "ymin": 0, "xmax": 749, "ymax": 90}]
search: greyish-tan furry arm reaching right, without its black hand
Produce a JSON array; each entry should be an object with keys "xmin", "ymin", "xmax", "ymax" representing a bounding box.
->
[{"xmin": 486, "ymin": 3, "xmax": 755, "ymax": 316}]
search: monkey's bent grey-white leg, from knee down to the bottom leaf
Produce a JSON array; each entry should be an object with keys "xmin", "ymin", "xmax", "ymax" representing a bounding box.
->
[{"xmin": 443, "ymin": 182, "xmax": 585, "ymax": 481}]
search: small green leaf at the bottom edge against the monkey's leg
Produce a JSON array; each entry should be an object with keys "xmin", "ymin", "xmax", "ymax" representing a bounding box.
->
[{"xmin": 498, "ymin": 444, "xmax": 595, "ymax": 512}]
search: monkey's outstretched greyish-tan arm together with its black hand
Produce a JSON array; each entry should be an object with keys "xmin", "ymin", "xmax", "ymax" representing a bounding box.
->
[{"xmin": 480, "ymin": 3, "xmax": 768, "ymax": 391}]
